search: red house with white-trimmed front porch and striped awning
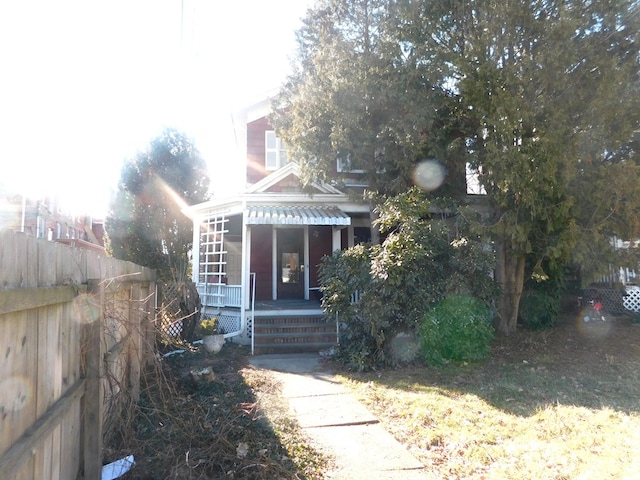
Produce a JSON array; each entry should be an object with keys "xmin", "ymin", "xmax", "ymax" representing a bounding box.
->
[{"xmin": 187, "ymin": 100, "xmax": 371, "ymax": 352}]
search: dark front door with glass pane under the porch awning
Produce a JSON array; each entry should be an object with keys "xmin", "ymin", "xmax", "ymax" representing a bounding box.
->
[{"xmin": 276, "ymin": 228, "xmax": 304, "ymax": 299}]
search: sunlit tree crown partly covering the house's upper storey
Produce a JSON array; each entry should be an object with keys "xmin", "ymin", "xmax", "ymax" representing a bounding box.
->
[{"xmin": 272, "ymin": 0, "xmax": 448, "ymax": 194}]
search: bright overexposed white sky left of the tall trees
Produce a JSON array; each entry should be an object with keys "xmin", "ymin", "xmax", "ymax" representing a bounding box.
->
[{"xmin": 0, "ymin": 0, "xmax": 312, "ymax": 217}]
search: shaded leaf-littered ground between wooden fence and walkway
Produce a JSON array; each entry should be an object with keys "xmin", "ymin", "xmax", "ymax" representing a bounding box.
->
[{"xmin": 105, "ymin": 344, "xmax": 310, "ymax": 480}]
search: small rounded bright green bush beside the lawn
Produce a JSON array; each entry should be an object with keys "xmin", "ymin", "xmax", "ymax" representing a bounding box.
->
[{"xmin": 418, "ymin": 295, "xmax": 494, "ymax": 365}]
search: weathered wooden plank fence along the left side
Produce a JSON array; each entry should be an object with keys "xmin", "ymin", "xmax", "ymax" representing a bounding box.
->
[{"xmin": 0, "ymin": 230, "xmax": 155, "ymax": 480}]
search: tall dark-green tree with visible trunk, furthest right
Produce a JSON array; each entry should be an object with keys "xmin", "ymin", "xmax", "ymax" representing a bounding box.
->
[{"xmin": 436, "ymin": 0, "xmax": 640, "ymax": 334}]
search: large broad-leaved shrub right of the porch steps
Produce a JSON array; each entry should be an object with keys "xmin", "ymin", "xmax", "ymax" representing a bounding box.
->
[{"xmin": 320, "ymin": 189, "xmax": 498, "ymax": 370}]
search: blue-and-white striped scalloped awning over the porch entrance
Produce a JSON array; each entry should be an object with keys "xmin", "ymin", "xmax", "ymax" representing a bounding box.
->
[{"xmin": 244, "ymin": 205, "xmax": 351, "ymax": 225}]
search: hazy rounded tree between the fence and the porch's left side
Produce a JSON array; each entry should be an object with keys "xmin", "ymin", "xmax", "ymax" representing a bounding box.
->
[{"xmin": 105, "ymin": 129, "xmax": 209, "ymax": 281}]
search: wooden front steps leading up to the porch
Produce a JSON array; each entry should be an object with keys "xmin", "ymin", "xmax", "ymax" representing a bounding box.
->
[{"xmin": 253, "ymin": 315, "xmax": 337, "ymax": 355}]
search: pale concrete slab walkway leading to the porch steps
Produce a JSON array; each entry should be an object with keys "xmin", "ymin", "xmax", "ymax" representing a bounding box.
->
[{"xmin": 250, "ymin": 354, "xmax": 436, "ymax": 480}]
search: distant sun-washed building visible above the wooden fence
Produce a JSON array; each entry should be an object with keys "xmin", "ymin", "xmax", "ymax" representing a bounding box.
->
[{"xmin": 0, "ymin": 185, "xmax": 105, "ymax": 253}]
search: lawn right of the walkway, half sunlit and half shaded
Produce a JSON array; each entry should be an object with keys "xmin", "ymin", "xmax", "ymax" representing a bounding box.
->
[{"xmin": 340, "ymin": 319, "xmax": 640, "ymax": 480}]
